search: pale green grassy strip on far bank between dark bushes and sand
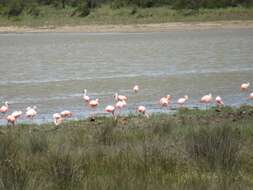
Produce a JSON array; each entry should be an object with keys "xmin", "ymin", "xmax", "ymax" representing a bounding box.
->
[{"xmin": 0, "ymin": 5, "xmax": 253, "ymax": 27}]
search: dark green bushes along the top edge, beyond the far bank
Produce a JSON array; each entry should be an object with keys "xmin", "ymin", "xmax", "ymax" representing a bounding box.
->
[{"xmin": 0, "ymin": 0, "xmax": 253, "ymax": 16}]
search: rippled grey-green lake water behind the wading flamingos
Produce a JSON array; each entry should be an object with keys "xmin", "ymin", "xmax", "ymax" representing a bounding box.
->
[{"xmin": 0, "ymin": 29, "xmax": 253, "ymax": 124}]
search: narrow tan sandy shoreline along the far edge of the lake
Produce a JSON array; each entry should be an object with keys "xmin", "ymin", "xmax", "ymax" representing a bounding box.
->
[{"xmin": 0, "ymin": 20, "xmax": 253, "ymax": 33}]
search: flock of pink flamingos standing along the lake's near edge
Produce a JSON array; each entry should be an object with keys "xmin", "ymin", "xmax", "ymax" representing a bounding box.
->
[{"xmin": 0, "ymin": 82, "xmax": 253, "ymax": 126}]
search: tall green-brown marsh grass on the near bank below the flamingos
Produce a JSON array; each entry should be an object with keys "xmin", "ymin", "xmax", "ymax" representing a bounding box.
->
[{"xmin": 0, "ymin": 106, "xmax": 253, "ymax": 190}]
